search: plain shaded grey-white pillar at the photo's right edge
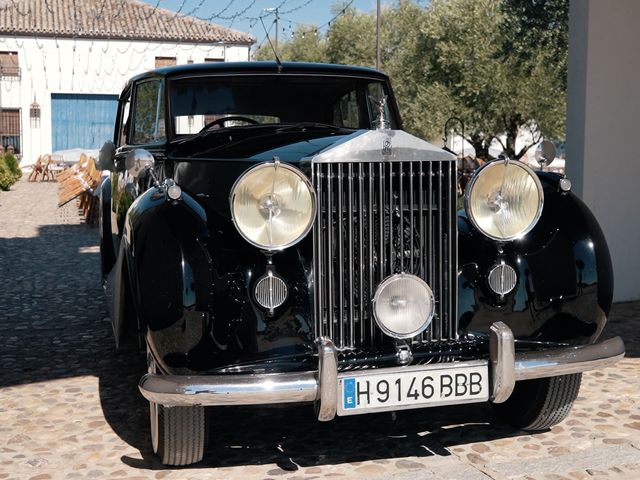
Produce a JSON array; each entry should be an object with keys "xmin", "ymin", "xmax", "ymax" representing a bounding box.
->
[{"xmin": 567, "ymin": 0, "xmax": 640, "ymax": 301}]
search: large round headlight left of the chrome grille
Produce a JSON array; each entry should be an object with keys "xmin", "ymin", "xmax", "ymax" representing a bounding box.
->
[{"xmin": 231, "ymin": 162, "xmax": 315, "ymax": 250}]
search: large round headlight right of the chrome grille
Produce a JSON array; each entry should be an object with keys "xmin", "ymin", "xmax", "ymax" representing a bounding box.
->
[{"xmin": 465, "ymin": 160, "xmax": 544, "ymax": 241}]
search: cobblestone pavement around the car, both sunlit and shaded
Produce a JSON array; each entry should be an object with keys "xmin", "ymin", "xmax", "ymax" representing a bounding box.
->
[{"xmin": 0, "ymin": 181, "xmax": 640, "ymax": 480}]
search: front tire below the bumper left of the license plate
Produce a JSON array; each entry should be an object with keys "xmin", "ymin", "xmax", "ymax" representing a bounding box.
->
[{"xmin": 147, "ymin": 348, "xmax": 207, "ymax": 465}]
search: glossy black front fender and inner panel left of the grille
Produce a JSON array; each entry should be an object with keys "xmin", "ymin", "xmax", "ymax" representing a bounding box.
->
[{"xmin": 124, "ymin": 184, "xmax": 313, "ymax": 374}]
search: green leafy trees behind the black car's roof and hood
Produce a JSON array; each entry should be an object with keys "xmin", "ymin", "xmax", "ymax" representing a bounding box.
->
[{"xmin": 256, "ymin": 0, "xmax": 568, "ymax": 158}]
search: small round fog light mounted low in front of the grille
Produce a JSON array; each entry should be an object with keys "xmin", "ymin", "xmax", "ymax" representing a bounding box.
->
[{"xmin": 373, "ymin": 273, "xmax": 435, "ymax": 338}]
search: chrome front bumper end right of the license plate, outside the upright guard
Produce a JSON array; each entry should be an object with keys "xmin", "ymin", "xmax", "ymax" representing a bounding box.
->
[{"xmin": 515, "ymin": 337, "xmax": 624, "ymax": 380}]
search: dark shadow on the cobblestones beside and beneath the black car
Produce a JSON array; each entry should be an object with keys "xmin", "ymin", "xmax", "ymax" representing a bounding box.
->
[{"xmin": 0, "ymin": 225, "xmax": 640, "ymax": 471}]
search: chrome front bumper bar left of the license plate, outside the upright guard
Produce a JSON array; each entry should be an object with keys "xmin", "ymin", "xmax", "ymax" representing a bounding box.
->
[{"xmin": 138, "ymin": 372, "xmax": 318, "ymax": 406}]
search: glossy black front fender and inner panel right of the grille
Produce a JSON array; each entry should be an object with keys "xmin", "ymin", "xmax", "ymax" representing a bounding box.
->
[{"xmin": 458, "ymin": 174, "xmax": 613, "ymax": 344}]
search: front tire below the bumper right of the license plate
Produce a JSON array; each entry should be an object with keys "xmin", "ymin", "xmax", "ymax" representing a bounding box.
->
[{"xmin": 494, "ymin": 373, "xmax": 582, "ymax": 431}]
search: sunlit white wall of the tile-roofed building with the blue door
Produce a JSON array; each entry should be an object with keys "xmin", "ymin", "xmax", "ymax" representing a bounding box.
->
[{"xmin": 0, "ymin": 36, "xmax": 249, "ymax": 165}]
